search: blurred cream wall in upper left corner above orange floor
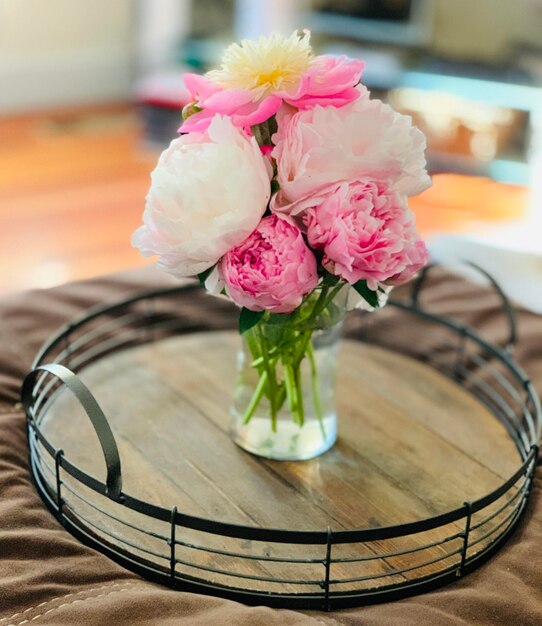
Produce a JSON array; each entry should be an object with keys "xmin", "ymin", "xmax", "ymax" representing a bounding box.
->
[{"xmin": 0, "ymin": 0, "xmax": 136, "ymax": 113}]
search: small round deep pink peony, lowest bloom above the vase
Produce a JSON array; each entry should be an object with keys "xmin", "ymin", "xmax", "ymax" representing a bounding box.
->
[{"xmin": 220, "ymin": 215, "xmax": 318, "ymax": 313}]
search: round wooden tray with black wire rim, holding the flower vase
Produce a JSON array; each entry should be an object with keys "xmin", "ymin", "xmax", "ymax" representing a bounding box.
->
[{"xmin": 26, "ymin": 280, "xmax": 536, "ymax": 608}]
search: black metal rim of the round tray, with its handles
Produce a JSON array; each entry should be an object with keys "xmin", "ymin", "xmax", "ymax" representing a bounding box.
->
[{"xmin": 22, "ymin": 266, "xmax": 542, "ymax": 609}]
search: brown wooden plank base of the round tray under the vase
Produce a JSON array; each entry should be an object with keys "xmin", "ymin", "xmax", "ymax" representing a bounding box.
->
[{"xmin": 38, "ymin": 332, "xmax": 520, "ymax": 591}]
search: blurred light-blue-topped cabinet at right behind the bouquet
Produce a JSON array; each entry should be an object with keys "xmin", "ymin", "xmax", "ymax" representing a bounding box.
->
[{"xmin": 314, "ymin": 40, "xmax": 542, "ymax": 185}]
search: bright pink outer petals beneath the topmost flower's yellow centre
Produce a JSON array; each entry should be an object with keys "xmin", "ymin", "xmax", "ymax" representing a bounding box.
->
[{"xmin": 179, "ymin": 55, "xmax": 364, "ymax": 133}]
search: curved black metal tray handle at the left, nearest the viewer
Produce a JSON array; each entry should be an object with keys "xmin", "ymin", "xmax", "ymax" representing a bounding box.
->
[{"xmin": 21, "ymin": 363, "xmax": 122, "ymax": 500}]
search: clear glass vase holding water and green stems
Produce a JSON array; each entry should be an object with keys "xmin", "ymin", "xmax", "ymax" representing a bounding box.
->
[{"xmin": 231, "ymin": 293, "xmax": 346, "ymax": 461}]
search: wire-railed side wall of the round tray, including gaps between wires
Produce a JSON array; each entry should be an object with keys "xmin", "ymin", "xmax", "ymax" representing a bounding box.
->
[{"xmin": 22, "ymin": 270, "xmax": 542, "ymax": 610}]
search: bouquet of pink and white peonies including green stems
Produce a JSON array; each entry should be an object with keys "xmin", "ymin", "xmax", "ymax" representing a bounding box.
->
[{"xmin": 133, "ymin": 31, "xmax": 430, "ymax": 438}]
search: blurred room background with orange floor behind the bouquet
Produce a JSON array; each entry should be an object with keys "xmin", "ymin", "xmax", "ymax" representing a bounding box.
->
[{"xmin": 0, "ymin": 0, "xmax": 542, "ymax": 312}]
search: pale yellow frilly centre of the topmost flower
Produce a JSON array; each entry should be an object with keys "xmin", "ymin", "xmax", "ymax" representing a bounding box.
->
[{"xmin": 207, "ymin": 31, "xmax": 313, "ymax": 98}]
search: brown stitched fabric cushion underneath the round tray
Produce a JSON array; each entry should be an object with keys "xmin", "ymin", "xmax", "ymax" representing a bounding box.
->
[{"xmin": 0, "ymin": 269, "xmax": 542, "ymax": 626}]
